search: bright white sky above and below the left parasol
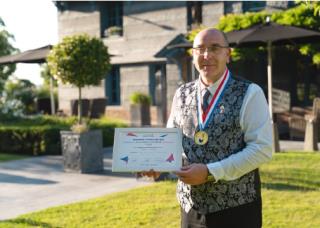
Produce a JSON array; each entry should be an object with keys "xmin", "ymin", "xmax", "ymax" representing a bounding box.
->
[{"xmin": 0, "ymin": 0, "xmax": 58, "ymax": 85}]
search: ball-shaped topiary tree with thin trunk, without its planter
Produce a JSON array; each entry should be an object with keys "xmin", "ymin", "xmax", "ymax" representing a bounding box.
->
[{"xmin": 47, "ymin": 34, "xmax": 111, "ymax": 125}]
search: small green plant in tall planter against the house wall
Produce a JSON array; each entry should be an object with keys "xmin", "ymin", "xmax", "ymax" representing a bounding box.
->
[{"xmin": 130, "ymin": 92, "xmax": 151, "ymax": 127}]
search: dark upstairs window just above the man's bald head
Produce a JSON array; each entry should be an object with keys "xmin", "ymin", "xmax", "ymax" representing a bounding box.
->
[{"xmin": 187, "ymin": 1, "xmax": 202, "ymax": 30}]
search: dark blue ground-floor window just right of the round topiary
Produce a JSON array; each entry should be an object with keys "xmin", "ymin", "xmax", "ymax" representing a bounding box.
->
[{"xmin": 105, "ymin": 66, "xmax": 120, "ymax": 105}]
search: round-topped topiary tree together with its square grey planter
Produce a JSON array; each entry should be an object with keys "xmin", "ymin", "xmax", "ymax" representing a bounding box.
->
[{"xmin": 47, "ymin": 35, "xmax": 110, "ymax": 173}]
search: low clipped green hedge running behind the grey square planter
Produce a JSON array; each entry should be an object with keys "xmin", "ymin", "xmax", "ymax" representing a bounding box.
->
[{"xmin": 0, "ymin": 116, "xmax": 126, "ymax": 155}]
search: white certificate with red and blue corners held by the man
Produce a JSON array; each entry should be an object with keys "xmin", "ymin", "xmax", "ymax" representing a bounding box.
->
[{"xmin": 112, "ymin": 128, "xmax": 182, "ymax": 172}]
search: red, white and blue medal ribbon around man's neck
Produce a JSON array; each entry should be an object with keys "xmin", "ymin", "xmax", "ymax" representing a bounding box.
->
[{"xmin": 198, "ymin": 69, "xmax": 230, "ymax": 130}]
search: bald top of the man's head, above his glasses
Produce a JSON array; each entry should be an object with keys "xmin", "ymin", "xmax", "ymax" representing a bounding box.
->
[{"xmin": 193, "ymin": 28, "xmax": 229, "ymax": 47}]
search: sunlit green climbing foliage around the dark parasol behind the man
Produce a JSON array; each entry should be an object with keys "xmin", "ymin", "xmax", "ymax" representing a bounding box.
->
[{"xmin": 187, "ymin": 2, "xmax": 320, "ymax": 65}]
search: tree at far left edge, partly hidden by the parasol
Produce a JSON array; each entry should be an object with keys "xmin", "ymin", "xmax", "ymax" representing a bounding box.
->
[{"xmin": 0, "ymin": 18, "xmax": 18, "ymax": 94}]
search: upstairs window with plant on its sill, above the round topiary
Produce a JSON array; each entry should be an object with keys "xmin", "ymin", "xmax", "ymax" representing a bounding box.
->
[{"xmin": 100, "ymin": 1, "xmax": 123, "ymax": 37}]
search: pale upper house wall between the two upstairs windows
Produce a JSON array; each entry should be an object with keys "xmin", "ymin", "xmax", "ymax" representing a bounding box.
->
[{"xmin": 104, "ymin": 2, "xmax": 187, "ymax": 64}]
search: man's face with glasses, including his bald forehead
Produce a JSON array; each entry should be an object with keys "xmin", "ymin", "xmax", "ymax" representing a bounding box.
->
[{"xmin": 192, "ymin": 30, "xmax": 230, "ymax": 83}]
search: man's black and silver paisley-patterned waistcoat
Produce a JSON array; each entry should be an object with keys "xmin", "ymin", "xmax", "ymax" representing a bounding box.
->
[{"xmin": 173, "ymin": 77, "xmax": 260, "ymax": 214}]
